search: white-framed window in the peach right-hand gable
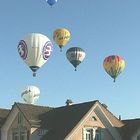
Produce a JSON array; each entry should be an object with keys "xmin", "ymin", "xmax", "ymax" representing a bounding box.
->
[{"xmin": 83, "ymin": 127, "xmax": 101, "ymax": 140}]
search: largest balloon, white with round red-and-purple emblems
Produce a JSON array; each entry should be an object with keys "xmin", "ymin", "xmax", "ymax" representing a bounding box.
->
[{"xmin": 18, "ymin": 33, "xmax": 53, "ymax": 76}]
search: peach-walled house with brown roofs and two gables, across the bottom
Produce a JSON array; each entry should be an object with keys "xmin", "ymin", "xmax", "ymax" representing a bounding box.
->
[{"xmin": 0, "ymin": 100, "xmax": 140, "ymax": 140}]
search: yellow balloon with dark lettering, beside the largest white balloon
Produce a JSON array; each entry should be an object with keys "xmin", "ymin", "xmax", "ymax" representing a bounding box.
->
[{"xmin": 53, "ymin": 28, "xmax": 71, "ymax": 51}]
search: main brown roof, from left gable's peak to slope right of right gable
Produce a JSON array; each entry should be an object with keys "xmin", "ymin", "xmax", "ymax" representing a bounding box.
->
[{"xmin": 16, "ymin": 101, "xmax": 123, "ymax": 140}]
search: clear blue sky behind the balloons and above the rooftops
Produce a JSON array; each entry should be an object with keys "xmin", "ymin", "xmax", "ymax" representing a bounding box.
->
[{"xmin": 0, "ymin": 0, "xmax": 140, "ymax": 119}]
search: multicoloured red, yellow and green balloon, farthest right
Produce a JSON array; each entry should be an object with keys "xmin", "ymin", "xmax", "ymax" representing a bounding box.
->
[{"xmin": 103, "ymin": 55, "xmax": 125, "ymax": 82}]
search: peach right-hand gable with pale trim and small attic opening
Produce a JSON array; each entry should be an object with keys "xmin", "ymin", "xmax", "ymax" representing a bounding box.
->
[{"xmin": 65, "ymin": 102, "xmax": 123, "ymax": 140}]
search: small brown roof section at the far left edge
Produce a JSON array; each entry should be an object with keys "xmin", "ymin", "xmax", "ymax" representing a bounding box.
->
[{"xmin": 0, "ymin": 108, "xmax": 10, "ymax": 127}]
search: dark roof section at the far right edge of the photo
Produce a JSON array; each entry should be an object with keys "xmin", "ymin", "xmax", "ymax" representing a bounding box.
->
[{"xmin": 121, "ymin": 118, "xmax": 140, "ymax": 140}]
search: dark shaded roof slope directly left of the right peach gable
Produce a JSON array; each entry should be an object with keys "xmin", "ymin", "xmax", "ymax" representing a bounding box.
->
[{"xmin": 42, "ymin": 101, "xmax": 96, "ymax": 140}]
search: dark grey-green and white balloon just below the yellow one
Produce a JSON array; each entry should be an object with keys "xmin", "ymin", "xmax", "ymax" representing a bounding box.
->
[{"xmin": 66, "ymin": 47, "xmax": 86, "ymax": 71}]
